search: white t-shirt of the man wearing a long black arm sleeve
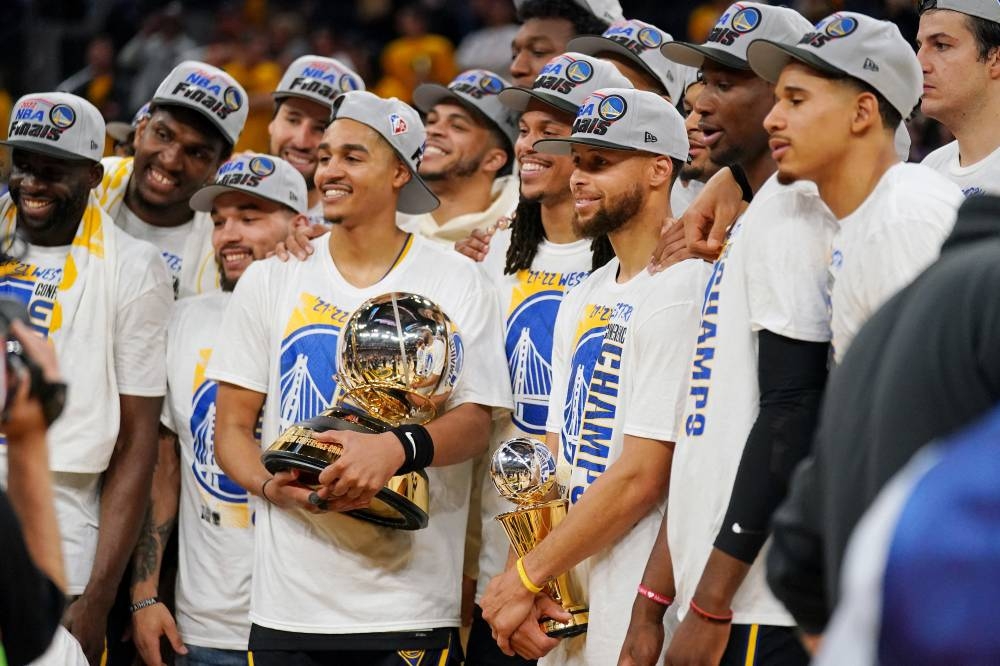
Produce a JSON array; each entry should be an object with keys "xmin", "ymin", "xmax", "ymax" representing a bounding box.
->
[{"xmin": 667, "ymin": 176, "xmax": 836, "ymax": 626}]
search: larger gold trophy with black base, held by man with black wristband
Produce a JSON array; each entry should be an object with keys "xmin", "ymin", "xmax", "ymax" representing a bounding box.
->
[{"xmin": 261, "ymin": 292, "xmax": 462, "ymax": 530}]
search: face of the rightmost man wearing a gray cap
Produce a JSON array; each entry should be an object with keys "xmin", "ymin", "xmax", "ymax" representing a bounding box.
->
[{"xmin": 764, "ymin": 62, "xmax": 858, "ymax": 184}]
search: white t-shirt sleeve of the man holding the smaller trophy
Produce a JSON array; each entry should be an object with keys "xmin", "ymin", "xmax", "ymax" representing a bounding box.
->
[{"xmin": 622, "ymin": 299, "xmax": 701, "ymax": 442}]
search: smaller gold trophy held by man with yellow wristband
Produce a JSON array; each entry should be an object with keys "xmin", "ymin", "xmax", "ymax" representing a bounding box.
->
[{"xmin": 490, "ymin": 437, "xmax": 589, "ymax": 638}]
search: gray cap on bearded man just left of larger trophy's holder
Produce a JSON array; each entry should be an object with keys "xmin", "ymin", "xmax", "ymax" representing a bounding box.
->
[{"xmin": 190, "ymin": 153, "xmax": 309, "ymax": 213}]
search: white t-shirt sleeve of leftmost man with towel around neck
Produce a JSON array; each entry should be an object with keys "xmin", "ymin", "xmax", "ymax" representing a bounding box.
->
[{"xmin": 114, "ymin": 246, "xmax": 174, "ymax": 397}]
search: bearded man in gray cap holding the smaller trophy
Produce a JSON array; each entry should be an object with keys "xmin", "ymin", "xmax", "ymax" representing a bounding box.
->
[{"xmin": 482, "ymin": 88, "xmax": 709, "ymax": 666}]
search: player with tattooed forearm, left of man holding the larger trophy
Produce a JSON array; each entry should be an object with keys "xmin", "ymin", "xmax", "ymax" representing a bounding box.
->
[{"xmin": 132, "ymin": 153, "xmax": 308, "ymax": 666}]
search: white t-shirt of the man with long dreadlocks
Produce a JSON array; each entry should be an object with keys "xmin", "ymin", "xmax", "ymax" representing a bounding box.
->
[{"xmin": 476, "ymin": 229, "xmax": 592, "ymax": 602}]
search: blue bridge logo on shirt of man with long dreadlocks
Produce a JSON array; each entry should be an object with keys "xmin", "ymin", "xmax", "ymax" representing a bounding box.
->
[{"xmin": 505, "ymin": 270, "xmax": 587, "ymax": 435}]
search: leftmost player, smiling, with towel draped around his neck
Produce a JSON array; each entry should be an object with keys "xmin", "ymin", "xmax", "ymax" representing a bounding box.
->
[{"xmin": 0, "ymin": 93, "xmax": 171, "ymax": 666}]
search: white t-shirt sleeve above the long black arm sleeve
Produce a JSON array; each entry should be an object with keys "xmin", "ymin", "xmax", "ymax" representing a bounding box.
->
[{"xmin": 742, "ymin": 192, "xmax": 833, "ymax": 342}]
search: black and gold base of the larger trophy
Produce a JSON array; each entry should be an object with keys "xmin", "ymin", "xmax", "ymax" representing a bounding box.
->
[{"xmin": 261, "ymin": 407, "xmax": 430, "ymax": 530}]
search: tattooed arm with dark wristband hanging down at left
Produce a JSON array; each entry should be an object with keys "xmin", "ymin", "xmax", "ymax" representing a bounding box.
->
[{"xmin": 132, "ymin": 425, "xmax": 187, "ymax": 666}]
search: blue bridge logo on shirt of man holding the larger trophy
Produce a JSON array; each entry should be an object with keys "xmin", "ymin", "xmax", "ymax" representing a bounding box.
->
[{"xmin": 279, "ymin": 293, "xmax": 351, "ymax": 430}]
